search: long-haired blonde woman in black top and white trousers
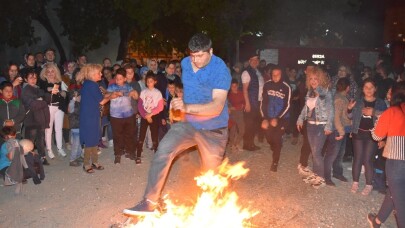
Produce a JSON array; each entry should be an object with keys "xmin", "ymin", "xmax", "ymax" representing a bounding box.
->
[{"xmin": 39, "ymin": 63, "xmax": 67, "ymax": 159}]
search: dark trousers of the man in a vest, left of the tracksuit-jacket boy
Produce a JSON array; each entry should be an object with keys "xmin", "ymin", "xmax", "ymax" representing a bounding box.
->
[{"xmin": 243, "ymin": 108, "xmax": 262, "ymax": 147}]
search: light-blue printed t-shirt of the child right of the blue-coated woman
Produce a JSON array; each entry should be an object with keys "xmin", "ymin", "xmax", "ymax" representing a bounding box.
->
[{"xmin": 107, "ymin": 83, "xmax": 134, "ymax": 118}]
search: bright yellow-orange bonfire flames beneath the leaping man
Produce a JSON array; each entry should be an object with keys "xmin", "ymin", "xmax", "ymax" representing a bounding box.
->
[{"xmin": 130, "ymin": 160, "xmax": 258, "ymax": 228}]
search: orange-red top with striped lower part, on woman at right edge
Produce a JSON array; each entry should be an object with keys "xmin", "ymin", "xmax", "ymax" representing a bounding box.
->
[{"xmin": 371, "ymin": 103, "xmax": 405, "ymax": 161}]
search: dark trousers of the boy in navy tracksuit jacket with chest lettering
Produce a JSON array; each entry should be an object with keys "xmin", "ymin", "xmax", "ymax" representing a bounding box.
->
[{"xmin": 264, "ymin": 120, "xmax": 284, "ymax": 164}]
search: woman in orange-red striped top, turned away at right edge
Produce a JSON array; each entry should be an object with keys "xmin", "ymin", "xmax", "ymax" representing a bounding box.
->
[{"xmin": 368, "ymin": 82, "xmax": 405, "ymax": 227}]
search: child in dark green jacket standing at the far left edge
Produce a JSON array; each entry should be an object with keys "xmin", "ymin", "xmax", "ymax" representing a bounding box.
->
[{"xmin": 0, "ymin": 81, "xmax": 25, "ymax": 142}]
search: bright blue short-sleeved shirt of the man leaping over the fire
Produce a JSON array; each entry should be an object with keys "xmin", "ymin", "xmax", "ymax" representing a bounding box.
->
[{"xmin": 181, "ymin": 55, "xmax": 232, "ymax": 130}]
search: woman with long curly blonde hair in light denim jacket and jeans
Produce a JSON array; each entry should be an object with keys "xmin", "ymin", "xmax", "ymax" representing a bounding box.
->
[{"xmin": 297, "ymin": 67, "xmax": 336, "ymax": 188}]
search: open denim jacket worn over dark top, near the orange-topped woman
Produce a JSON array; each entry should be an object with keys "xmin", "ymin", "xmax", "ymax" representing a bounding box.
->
[{"xmin": 348, "ymin": 96, "xmax": 387, "ymax": 134}]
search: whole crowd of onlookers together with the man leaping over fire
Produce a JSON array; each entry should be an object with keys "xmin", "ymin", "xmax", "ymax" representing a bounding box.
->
[{"xmin": 0, "ymin": 36, "xmax": 405, "ymax": 227}]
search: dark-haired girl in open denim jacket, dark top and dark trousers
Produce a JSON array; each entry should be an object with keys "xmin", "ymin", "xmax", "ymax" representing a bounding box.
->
[{"xmin": 348, "ymin": 79, "xmax": 387, "ymax": 195}]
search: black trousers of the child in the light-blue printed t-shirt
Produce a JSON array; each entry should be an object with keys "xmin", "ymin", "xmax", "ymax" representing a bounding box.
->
[{"xmin": 110, "ymin": 116, "xmax": 136, "ymax": 156}]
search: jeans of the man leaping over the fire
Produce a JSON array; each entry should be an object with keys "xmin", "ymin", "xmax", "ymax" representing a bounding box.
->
[{"xmin": 144, "ymin": 122, "xmax": 228, "ymax": 202}]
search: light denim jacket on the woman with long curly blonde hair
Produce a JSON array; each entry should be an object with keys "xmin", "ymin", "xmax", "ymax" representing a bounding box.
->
[{"xmin": 297, "ymin": 87, "xmax": 335, "ymax": 131}]
